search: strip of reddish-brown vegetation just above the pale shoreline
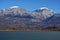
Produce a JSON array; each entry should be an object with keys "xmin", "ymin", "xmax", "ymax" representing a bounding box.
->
[{"xmin": 0, "ymin": 27, "xmax": 60, "ymax": 31}]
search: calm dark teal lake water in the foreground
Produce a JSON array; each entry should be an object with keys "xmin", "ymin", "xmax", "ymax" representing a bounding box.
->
[{"xmin": 0, "ymin": 31, "xmax": 60, "ymax": 40}]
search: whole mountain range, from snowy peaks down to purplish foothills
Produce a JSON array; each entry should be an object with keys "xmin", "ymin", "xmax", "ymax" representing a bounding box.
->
[{"xmin": 0, "ymin": 6, "xmax": 60, "ymax": 27}]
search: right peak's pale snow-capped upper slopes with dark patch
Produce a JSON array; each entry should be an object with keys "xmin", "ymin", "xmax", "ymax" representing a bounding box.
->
[{"xmin": 32, "ymin": 7, "xmax": 54, "ymax": 19}]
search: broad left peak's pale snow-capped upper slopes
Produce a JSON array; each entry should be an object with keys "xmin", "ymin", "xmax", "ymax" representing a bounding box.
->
[{"xmin": 0, "ymin": 6, "xmax": 30, "ymax": 16}]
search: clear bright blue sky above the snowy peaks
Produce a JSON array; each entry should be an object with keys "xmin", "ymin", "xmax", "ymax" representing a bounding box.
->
[{"xmin": 0, "ymin": 0, "xmax": 60, "ymax": 12}]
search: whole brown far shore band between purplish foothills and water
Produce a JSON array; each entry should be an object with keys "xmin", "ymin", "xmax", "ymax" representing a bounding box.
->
[{"xmin": 0, "ymin": 27, "xmax": 60, "ymax": 31}]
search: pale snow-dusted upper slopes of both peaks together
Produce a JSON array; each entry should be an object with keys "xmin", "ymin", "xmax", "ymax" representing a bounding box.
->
[{"xmin": 0, "ymin": 6, "xmax": 53, "ymax": 19}]
